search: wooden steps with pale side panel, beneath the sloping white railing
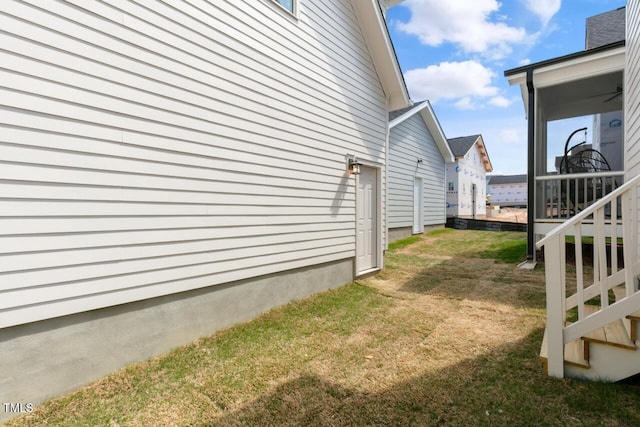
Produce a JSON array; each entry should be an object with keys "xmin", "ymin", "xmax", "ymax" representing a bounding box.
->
[{"xmin": 540, "ymin": 305, "xmax": 640, "ymax": 381}]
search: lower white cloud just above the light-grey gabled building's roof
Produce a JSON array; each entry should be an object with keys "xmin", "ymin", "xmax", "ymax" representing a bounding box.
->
[{"xmin": 404, "ymin": 61, "xmax": 501, "ymax": 109}]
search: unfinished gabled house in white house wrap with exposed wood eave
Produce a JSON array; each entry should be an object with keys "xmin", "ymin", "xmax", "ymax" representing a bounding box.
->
[{"xmin": 446, "ymin": 135, "xmax": 493, "ymax": 218}]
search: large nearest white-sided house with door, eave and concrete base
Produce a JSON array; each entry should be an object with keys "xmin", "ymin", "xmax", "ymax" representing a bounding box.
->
[{"xmin": 0, "ymin": 0, "xmax": 410, "ymax": 419}]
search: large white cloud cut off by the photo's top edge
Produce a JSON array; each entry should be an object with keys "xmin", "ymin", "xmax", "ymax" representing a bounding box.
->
[{"xmin": 396, "ymin": 0, "xmax": 528, "ymax": 59}]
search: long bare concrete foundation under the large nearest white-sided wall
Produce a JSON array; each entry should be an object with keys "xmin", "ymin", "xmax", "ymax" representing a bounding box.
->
[{"xmin": 0, "ymin": 259, "xmax": 354, "ymax": 421}]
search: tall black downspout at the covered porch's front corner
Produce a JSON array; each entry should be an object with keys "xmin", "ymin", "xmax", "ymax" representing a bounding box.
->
[{"xmin": 526, "ymin": 68, "xmax": 536, "ymax": 263}]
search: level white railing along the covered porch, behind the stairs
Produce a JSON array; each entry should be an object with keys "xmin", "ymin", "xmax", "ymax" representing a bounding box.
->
[{"xmin": 536, "ymin": 171, "xmax": 624, "ymax": 220}]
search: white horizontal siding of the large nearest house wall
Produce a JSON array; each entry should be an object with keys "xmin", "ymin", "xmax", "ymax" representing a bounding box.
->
[{"xmin": 0, "ymin": 0, "xmax": 386, "ymax": 327}]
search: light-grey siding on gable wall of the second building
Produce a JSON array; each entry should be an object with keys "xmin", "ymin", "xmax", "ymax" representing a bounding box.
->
[{"xmin": 388, "ymin": 114, "xmax": 446, "ymax": 228}]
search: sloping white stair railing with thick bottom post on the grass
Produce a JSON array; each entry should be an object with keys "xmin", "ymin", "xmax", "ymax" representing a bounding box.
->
[{"xmin": 537, "ymin": 175, "xmax": 640, "ymax": 378}]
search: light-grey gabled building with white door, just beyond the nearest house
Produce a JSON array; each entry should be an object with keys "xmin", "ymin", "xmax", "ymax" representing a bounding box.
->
[{"xmin": 387, "ymin": 101, "xmax": 454, "ymax": 242}]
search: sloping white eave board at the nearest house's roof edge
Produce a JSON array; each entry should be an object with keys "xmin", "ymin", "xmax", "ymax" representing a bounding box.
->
[{"xmin": 351, "ymin": 0, "xmax": 411, "ymax": 111}]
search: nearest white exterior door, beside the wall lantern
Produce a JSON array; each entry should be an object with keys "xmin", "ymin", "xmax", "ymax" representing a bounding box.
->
[{"xmin": 356, "ymin": 166, "xmax": 378, "ymax": 272}]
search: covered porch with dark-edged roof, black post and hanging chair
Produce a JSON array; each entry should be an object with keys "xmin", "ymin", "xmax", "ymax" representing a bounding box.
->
[{"xmin": 505, "ymin": 41, "xmax": 625, "ymax": 262}]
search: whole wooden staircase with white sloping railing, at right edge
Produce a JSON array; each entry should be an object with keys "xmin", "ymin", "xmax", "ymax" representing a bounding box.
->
[{"xmin": 536, "ymin": 175, "xmax": 640, "ymax": 381}]
